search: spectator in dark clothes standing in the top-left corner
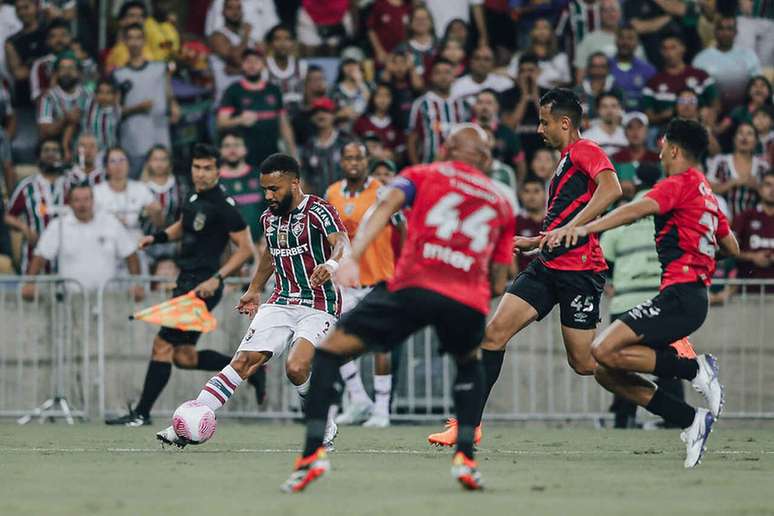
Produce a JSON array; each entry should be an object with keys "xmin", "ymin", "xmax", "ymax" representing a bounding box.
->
[{"xmin": 5, "ymin": 0, "xmax": 47, "ymax": 106}]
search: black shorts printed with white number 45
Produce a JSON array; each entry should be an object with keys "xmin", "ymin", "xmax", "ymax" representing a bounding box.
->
[{"xmin": 508, "ymin": 260, "xmax": 605, "ymax": 330}]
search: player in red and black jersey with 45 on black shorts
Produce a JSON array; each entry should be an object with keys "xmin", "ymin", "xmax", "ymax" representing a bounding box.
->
[{"xmin": 428, "ymin": 89, "xmax": 621, "ymax": 446}]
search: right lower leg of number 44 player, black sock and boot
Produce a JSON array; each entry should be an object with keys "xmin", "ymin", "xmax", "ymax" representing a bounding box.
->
[{"xmin": 451, "ymin": 352, "xmax": 484, "ymax": 491}]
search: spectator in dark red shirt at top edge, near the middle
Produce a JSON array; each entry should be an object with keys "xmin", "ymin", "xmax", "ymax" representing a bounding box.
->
[{"xmin": 366, "ymin": 0, "xmax": 411, "ymax": 68}]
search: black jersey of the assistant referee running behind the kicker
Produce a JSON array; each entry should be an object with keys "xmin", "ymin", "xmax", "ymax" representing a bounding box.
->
[{"xmin": 176, "ymin": 185, "xmax": 247, "ymax": 275}]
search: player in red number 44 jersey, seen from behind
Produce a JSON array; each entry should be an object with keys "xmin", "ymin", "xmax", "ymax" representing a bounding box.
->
[{"xmin": 282, "ymin": 124, "xmax": 515, "ymax": 492}]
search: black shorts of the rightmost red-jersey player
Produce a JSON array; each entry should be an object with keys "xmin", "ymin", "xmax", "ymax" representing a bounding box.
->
[{"xmin": 620, "ymin": 282, "xmax": 709, "ymax": 348}]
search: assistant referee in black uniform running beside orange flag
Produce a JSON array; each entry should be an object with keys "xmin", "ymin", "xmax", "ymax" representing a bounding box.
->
[{"xmin": 106, "ymin": 143, "xmax": 264, "ymax": 427}]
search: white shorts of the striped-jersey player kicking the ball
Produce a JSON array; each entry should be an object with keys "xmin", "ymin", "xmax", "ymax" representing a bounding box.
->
[{"xmin": 237, "ymin": 304, "xmax": 337, "ymax": 359}]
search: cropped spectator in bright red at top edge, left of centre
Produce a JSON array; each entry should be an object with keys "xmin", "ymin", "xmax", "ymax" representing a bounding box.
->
[{"xmin": 296, "ymin": 0, "xmax": 354, "ymax": 55}]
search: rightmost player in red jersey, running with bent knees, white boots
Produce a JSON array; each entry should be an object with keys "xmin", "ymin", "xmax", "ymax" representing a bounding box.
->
[{"xmin": 562, "ymin": 119, "xmax": 739, "ymax": 468}]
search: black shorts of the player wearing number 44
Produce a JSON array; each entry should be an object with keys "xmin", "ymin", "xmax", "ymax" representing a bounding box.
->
[{"xmin": 337, "ymin": 283, "xmax": 486, "ymax": 355}]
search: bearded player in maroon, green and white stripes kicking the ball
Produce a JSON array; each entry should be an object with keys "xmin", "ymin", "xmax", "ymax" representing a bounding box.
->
[{"xmin": 156, "ymin": 154, "xmax": 349, "ymax": 448}]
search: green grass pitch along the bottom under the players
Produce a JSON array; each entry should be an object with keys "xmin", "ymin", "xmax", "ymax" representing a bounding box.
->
[{"xmin": 0, "ymin": 420, "xmax": 774, "ymax": 516}]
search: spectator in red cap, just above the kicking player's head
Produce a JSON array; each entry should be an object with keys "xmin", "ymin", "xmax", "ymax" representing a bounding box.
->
[{"xmin": 301, "ymin": 97, "xmax": 352, "ymax": 195}]
